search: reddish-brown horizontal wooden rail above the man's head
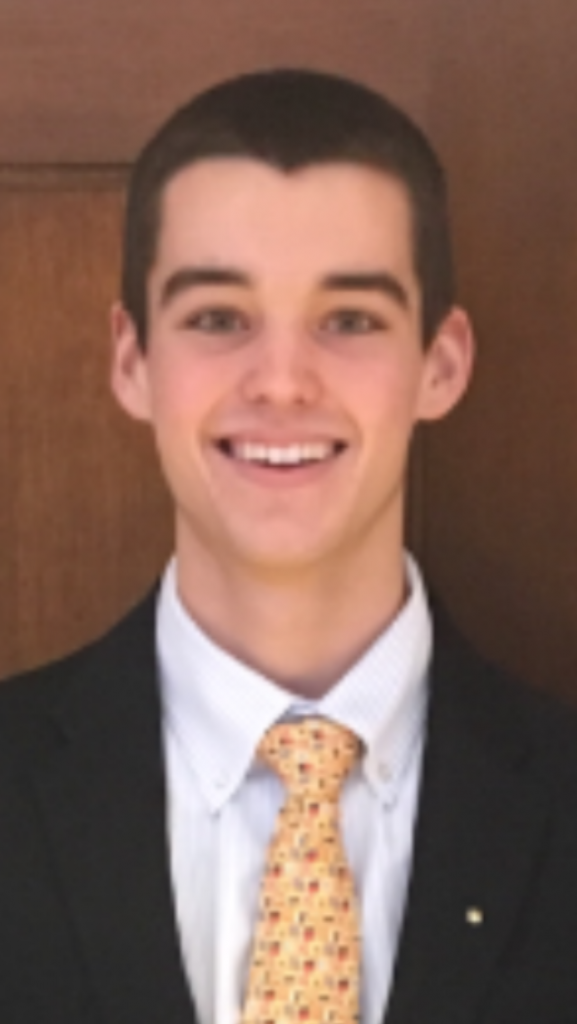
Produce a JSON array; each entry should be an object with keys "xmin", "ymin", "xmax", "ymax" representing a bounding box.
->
[{"xmin": 0, "ymin": 0, "xmax": 435, "ymax": 164}]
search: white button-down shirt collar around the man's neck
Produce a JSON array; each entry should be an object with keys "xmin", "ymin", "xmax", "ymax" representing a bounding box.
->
[{"xmin": 157, "ymin": 556, "xmax": 431, "ymax": 812}]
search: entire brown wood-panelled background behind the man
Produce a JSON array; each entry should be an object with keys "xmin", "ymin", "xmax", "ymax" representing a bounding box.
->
[{"xmin": 0, "ymin": 0, "xmax": 577, "ymax": 699}]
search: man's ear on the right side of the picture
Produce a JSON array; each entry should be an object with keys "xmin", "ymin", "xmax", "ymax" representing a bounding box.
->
[{"xmin": 417, "ymin": 307, "xmax": 475, "ymax": 420}]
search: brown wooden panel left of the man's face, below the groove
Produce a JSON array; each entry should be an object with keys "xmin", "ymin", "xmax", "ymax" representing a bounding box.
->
[{"xmin": 0, "ymin": 180, "xmax": 170, "ymax": 675}]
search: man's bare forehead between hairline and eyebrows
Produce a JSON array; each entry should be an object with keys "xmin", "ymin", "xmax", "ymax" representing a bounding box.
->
[{"xmin": 153, "ymin": 158, "xmax": 416, "ymax": 296}]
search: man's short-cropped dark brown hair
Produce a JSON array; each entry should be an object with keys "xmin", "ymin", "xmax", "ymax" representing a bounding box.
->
[{"xmin": 122, "ymin": 70, "xmax": 454, "ymax": 346}]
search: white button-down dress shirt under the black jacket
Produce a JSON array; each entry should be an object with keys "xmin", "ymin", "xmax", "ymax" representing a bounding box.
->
[{"xmin": 157, "ymin": 557, "xmax": 431, "ymax": 1024}]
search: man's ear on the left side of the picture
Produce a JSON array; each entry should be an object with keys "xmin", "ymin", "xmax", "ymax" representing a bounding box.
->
[{"xmin": 110, "ymin": 302, "xmax": 151, "ymax": 420}]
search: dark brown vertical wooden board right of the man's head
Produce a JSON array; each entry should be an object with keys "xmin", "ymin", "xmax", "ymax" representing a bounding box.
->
[{"xmin": 423, "ymin": 0, "xmax": 577, "ymax": 698}]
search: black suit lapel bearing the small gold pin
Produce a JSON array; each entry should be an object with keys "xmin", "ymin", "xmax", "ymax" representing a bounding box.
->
[{"xmin": 385, "ymin": 614, "xmax": 547, "ymax": 1024}]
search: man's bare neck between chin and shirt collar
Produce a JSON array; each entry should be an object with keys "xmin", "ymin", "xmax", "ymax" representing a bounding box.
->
[{"xmin": 176, "ymin": 528, "xmax": 406, "ymax": 699}]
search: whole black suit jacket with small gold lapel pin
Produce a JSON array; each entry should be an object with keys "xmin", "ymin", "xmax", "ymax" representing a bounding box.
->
[{"xmin": 0, "ymin": 598, "xmax": 577, "ymax": 1024}]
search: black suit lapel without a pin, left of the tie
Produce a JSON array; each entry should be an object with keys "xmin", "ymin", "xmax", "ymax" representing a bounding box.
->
[{"xmin": 35, "ymin": 599, "xmax": 195, "ymax": 1024}]
